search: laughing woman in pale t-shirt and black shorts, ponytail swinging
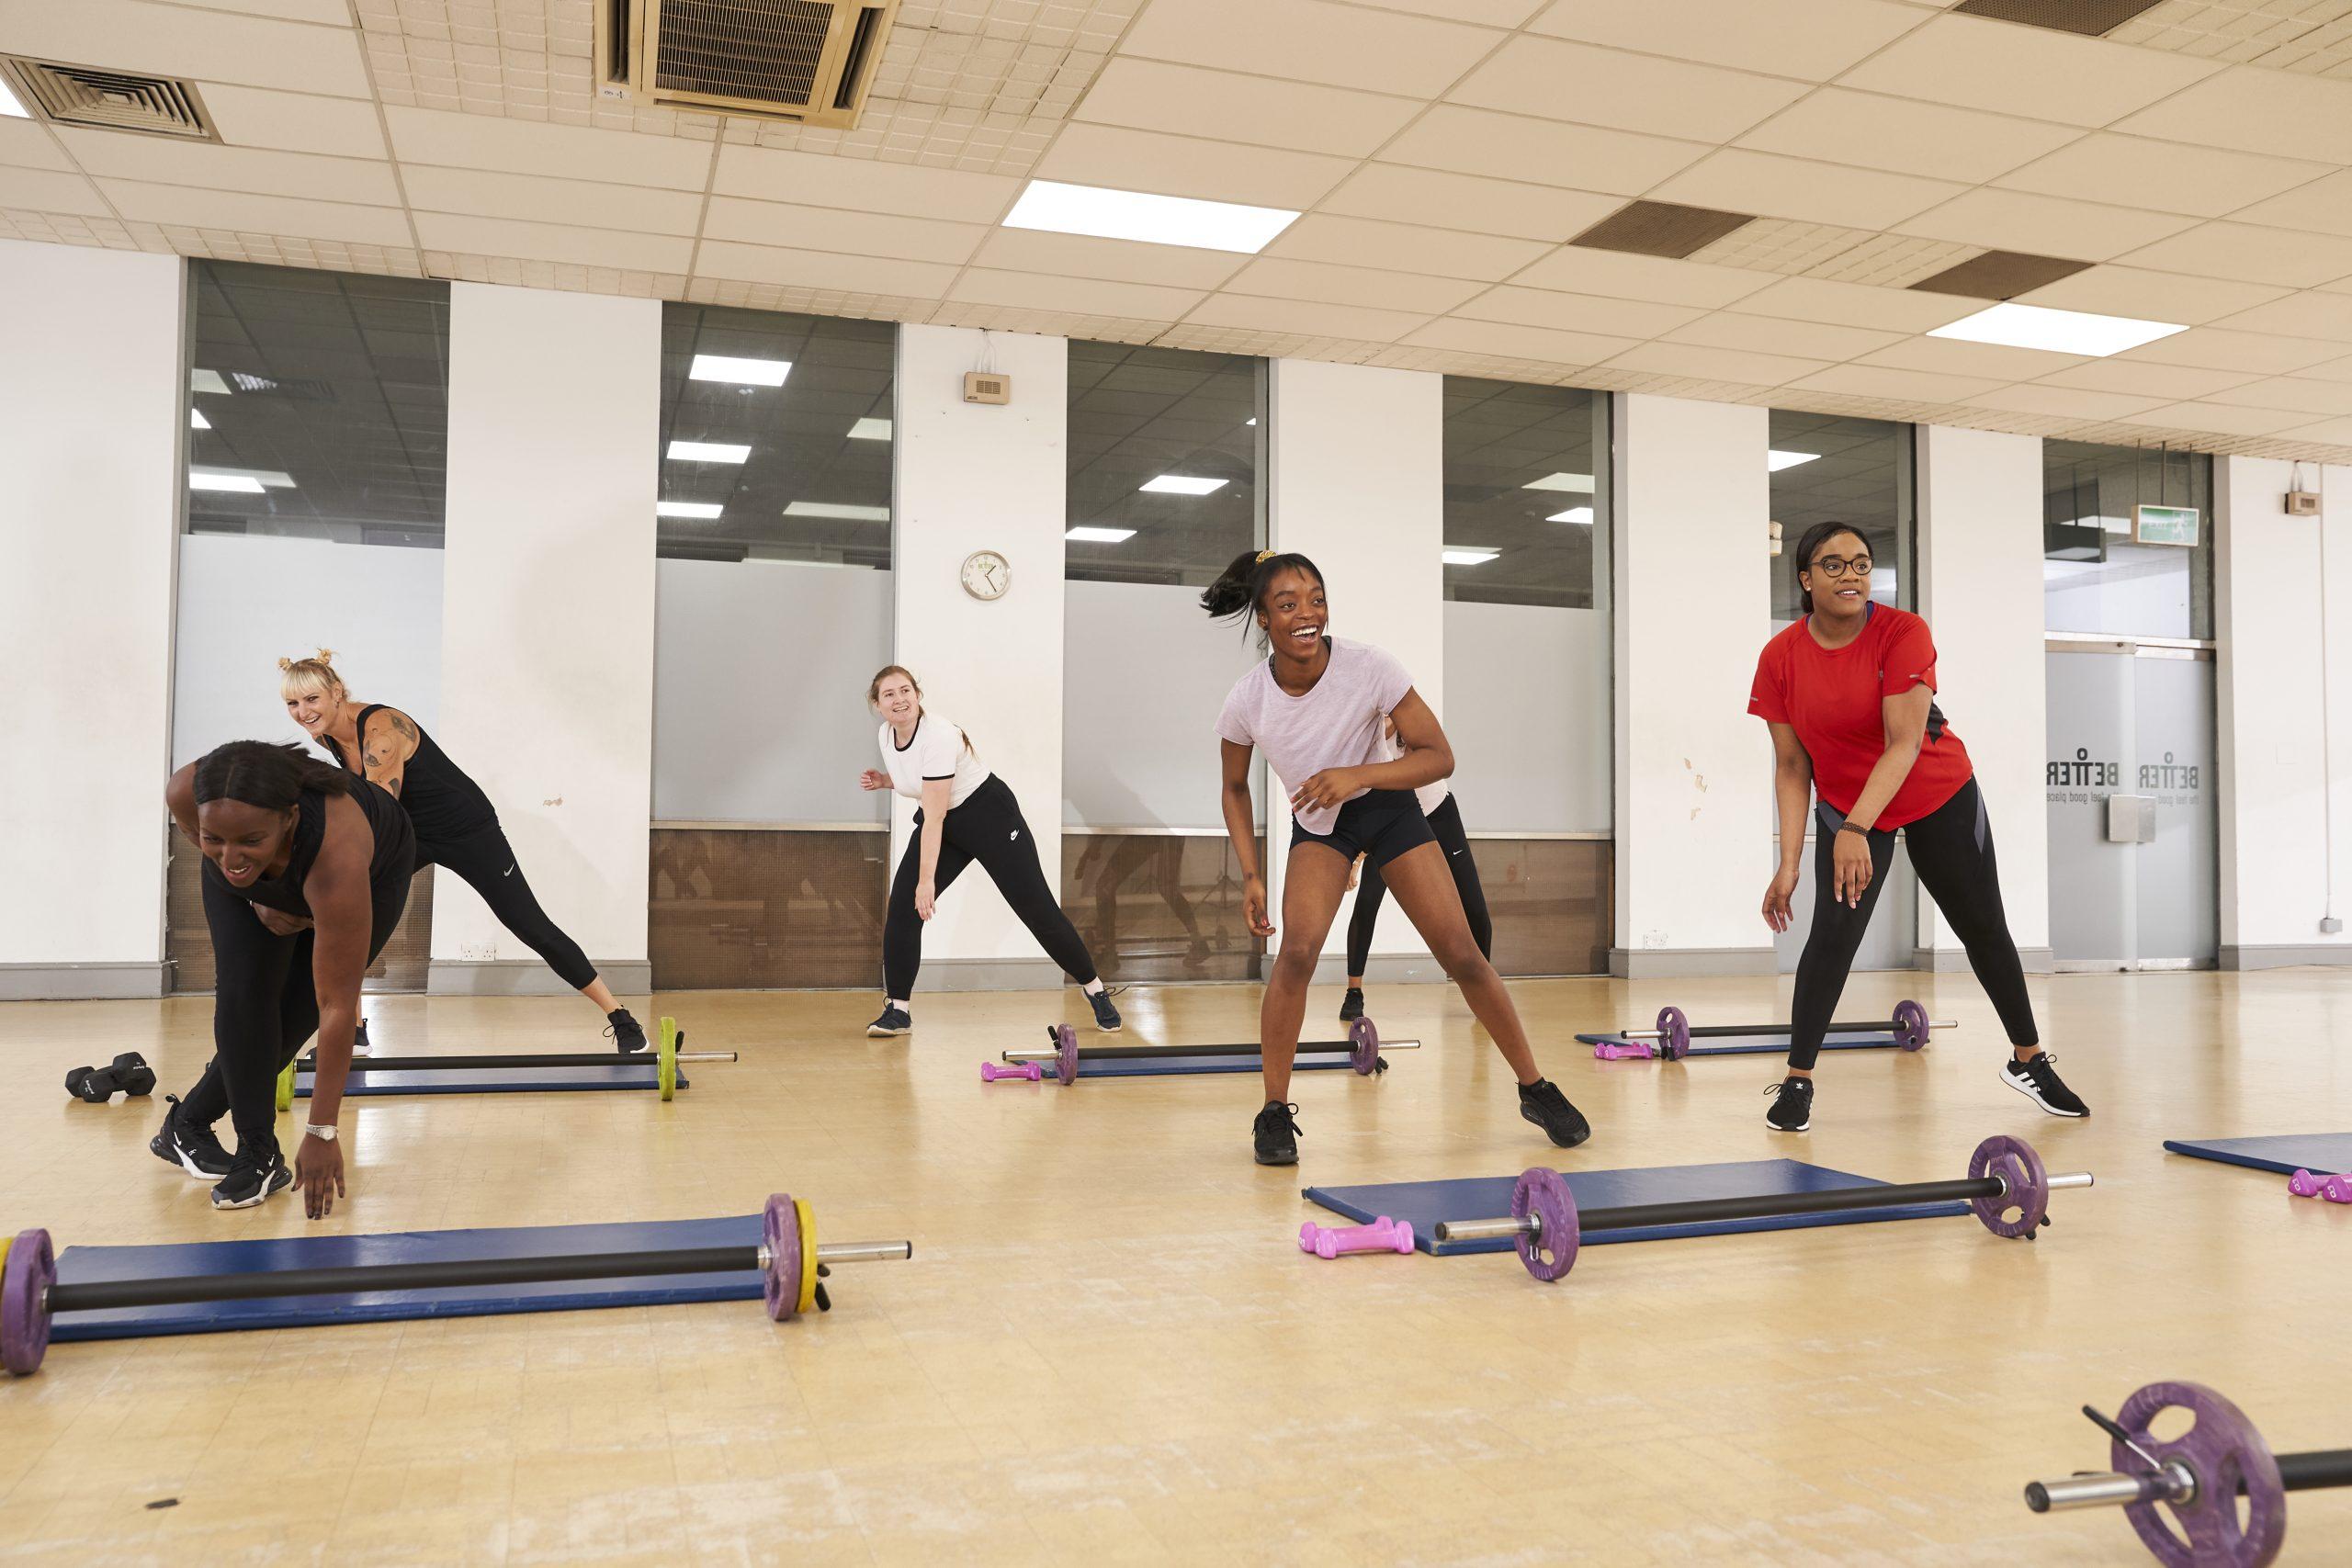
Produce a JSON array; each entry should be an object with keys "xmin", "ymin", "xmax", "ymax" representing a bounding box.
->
[{"xmin": 1200, "ymin": 550, "xmax": 1592, "ymax": 1166}]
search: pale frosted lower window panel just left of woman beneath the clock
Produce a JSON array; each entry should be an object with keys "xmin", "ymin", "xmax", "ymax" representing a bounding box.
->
[{"xmin": 654, "ymin": 559, "xmax": 894, "ymax": 823}]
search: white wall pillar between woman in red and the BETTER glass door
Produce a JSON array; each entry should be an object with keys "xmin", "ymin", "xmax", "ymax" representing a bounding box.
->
[{"xmin": 1919, "ymin": 425, "xmax": 2051, "ymax": 968}]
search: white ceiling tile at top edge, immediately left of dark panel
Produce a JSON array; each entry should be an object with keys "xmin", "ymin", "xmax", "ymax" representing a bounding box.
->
[{"xmin": 1529, "ymin": 0, "xmax": 1927, "ymax": 83}]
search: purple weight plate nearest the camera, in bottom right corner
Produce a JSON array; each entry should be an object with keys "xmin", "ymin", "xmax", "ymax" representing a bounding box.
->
[{"xmin": 2109, "ymin": 1382, "xmax": 2286, "ymax": 1568}]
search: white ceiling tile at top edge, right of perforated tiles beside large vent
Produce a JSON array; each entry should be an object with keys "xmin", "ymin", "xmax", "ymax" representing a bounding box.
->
[{"xmin": 1120, "ymin": 0, "xmax": 1496, "ymax": 98}]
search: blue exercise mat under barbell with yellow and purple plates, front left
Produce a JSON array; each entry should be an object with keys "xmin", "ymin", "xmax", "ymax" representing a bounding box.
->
[{"xmin": 51, "ymin": 1213, "xmax": 764, "ymax": 1340}]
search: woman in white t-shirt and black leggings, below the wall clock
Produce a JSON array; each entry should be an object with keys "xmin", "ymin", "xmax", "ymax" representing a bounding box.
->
[{"xmin": 858, "ymin": 665, "xmax": 1120, "ymax": 1034}]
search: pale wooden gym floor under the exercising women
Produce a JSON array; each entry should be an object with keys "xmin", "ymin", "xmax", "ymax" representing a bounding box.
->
[{"xmin": 0, "ymin": 971, "xmax": 2352, "ymax": 1568}]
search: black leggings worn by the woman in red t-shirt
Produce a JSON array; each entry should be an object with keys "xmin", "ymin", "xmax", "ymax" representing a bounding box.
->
[{"xmin": 1788, "ymin": 778, "xmax": 2041, "ymax": 1067}]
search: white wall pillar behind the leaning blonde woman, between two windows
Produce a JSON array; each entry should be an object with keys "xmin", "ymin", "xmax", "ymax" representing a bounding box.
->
[{"xmin": 433, "ymin": 282, "xmax": 661, "ymax": 989}]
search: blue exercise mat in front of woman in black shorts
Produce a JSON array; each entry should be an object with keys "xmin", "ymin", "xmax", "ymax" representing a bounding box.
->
[{"xmin": 1306, "ymin": 1159, "xmax": 1969, "ymax": 1258}]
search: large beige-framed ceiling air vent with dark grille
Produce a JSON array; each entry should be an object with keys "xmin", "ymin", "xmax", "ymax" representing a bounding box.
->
[{"xmin": 597, "ymin": 0, "xmax": 899, "ymax": 127}]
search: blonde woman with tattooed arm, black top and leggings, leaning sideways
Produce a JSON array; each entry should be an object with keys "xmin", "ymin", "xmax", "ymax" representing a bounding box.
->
[{"xmin": 277, "ymin": 649, "xmax": 647, "ymax": 1051}]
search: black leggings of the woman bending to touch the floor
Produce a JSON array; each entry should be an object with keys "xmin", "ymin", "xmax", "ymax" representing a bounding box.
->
[{"xmin": 179, "ymin": 865, "xmax": 409, "ymax": 1149}]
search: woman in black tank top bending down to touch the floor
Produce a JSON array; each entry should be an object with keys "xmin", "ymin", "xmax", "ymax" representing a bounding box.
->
[{"xmin": 148, "ymin": 740, "xmax": 416, "ymax": 1220}]
